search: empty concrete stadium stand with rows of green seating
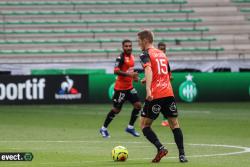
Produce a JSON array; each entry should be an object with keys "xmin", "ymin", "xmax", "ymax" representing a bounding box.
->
[{"xmin": 0, "ymin": 0, "xmax": 250, "ymax": 71}]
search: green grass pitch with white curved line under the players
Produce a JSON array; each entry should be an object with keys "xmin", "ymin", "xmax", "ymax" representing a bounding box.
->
[{"xmin": 0, "ymin": 102, "xmax": 250, "ymax": 167}]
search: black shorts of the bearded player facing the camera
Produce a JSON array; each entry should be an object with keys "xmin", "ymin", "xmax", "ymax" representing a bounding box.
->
[{"xmin": 112, "ymin": 88, "xmax": 140, "ymax": 109}]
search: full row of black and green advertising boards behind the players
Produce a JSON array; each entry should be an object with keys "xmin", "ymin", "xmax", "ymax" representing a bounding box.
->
[{"xmin": 0, "ymin": 71, "xmax": 250, "ymax": 104}]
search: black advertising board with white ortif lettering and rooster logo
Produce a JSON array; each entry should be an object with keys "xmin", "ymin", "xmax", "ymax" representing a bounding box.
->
[{"xmin": 0, "ymin": 75, "xmax": 88, "ymax": 104}]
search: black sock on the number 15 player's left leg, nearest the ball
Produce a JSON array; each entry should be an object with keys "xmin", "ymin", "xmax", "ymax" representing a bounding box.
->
[{"xmin": 142, "ymin": 127, "xmax": 164, "ymax": 151}]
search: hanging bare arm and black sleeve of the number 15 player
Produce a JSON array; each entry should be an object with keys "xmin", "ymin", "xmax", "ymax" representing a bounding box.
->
[{"xmin": 140, "ymin": 52, "xmax": 153, "ymax": 101}]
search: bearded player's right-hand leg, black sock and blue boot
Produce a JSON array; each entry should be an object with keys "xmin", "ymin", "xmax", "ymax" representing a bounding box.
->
[{"xmin": 125, "ymin": 89, "xmax": 142, "ymax": 137}]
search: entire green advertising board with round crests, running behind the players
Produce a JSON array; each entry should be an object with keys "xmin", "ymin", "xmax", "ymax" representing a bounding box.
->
[{"xmin": 89, "ymin": 73, "xmax": 250, "ymax": 103}]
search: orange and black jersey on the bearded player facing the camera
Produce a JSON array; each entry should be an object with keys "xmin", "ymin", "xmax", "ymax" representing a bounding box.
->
[{"xmin": 114, "ymin": 53, "xmax": 135, "ymax": 90}]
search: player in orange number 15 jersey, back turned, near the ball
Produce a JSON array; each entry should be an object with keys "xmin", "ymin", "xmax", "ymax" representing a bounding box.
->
[{"xmin": 137, "ymin": 30, "xmax": 188, "ymax": 163}]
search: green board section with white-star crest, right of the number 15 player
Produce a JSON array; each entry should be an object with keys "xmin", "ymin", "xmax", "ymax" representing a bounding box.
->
[{"xmin": 172, "ymin": 72, "xmax": 250, "ymax": 102}]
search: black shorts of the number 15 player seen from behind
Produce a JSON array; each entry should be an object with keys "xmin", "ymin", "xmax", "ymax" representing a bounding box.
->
[{"xmin": 141, "ymin": 96, "xmax": 178, "ymax": 120}]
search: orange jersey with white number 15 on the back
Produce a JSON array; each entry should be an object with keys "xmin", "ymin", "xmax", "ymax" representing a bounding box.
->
[{"xmin": 140, "ymin": 48, "xmax": 174, "ymax": 99}]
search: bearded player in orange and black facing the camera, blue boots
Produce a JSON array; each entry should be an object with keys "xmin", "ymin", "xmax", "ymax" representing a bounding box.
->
[{"xmin": 100, "ymin": 40, "xmax": 142, "ymax": 138}]
